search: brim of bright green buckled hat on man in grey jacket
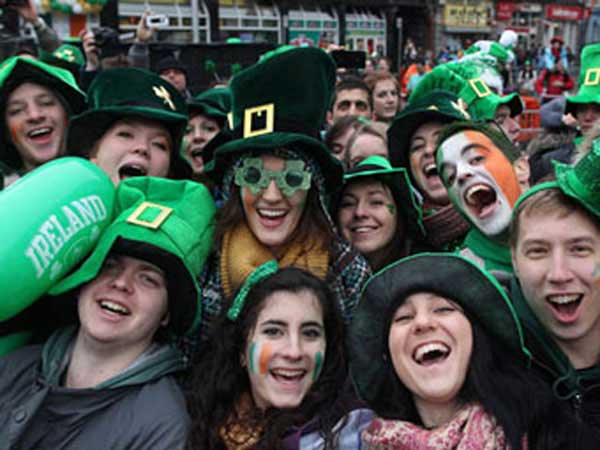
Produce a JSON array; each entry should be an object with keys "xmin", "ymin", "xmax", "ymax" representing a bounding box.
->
[{"xmin": 49, "ymin": 222, "xmax": 200, "ymax": 335}]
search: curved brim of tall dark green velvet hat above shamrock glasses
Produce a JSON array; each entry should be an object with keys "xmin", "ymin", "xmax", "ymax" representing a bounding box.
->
[{"xmin": 205, "ymin": 132, "xmax": 343, "ymax": 192}]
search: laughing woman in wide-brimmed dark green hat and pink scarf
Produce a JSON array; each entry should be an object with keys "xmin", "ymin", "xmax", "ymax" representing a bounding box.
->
[{"xmin": 348, "ymin": 253, "xmax": 597, "ymax": 450}]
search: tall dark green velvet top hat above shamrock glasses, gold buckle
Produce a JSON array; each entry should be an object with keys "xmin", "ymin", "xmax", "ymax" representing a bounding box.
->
[{"xmin": 207, "ymin": 47, "xmax": 342, "ymax": 191}]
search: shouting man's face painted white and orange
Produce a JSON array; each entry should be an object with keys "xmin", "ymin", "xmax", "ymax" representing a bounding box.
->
[{"xmin": 437, "ymin": 131, "xmax": 520, "ymax": 236}]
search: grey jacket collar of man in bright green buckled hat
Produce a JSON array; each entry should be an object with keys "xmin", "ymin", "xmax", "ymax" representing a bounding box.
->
[{"xmin": 41, "ymin": 326, "xmax": 187, "ymax": 390}]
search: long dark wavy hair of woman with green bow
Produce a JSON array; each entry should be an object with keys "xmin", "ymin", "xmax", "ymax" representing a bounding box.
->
[{"xmin": 186, "ymin": 267, "xmax": 347, "ymax": 450}]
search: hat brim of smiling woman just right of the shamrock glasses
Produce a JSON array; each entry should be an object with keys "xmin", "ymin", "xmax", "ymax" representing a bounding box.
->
[{"xmin": 336, "ymin": 165, "xmax": 427, "ymax": 238}]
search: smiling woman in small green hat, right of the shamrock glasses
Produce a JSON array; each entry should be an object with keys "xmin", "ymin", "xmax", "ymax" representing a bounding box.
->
[{"xmin": 334, "ymin": 156, "xmax": 425, "ymax": 272}]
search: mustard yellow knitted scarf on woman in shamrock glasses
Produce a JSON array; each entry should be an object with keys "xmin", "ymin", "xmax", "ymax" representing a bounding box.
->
[{"xmin": 220, "ymin": 222, "xmax": 329, "ymax": 297}]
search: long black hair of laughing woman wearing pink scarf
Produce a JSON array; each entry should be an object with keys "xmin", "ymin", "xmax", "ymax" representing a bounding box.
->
[{"xmin": 373, "ymin": 298, "xmax": 558, "ymax": 450}]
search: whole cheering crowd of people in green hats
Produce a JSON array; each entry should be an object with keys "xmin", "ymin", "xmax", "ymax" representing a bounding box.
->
[{"xmin": 0, "ymin": 2, "xmax": 600, "ymax": 450}]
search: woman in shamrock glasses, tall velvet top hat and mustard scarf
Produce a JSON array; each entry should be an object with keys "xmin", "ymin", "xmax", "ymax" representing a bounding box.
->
[{"xmin": 189, "ymin": 48, "xmax": 369, "ymax": 352}]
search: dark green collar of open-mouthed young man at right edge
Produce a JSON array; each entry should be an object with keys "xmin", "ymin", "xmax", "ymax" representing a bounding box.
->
[{"xmin": 510, "ymin": 277, "xmax": 600, "ymax": 400}]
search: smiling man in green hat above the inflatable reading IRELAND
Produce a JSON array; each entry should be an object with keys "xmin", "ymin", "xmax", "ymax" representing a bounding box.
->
[{"xmin": 0, "ymin": 57, "xmax": 85, "ymax": 189}]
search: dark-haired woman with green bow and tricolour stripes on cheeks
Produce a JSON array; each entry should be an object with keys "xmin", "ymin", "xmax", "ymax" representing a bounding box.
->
[{"xmin": 188, "ymin": 268, "xmax": 370, "ymax": 450}]
